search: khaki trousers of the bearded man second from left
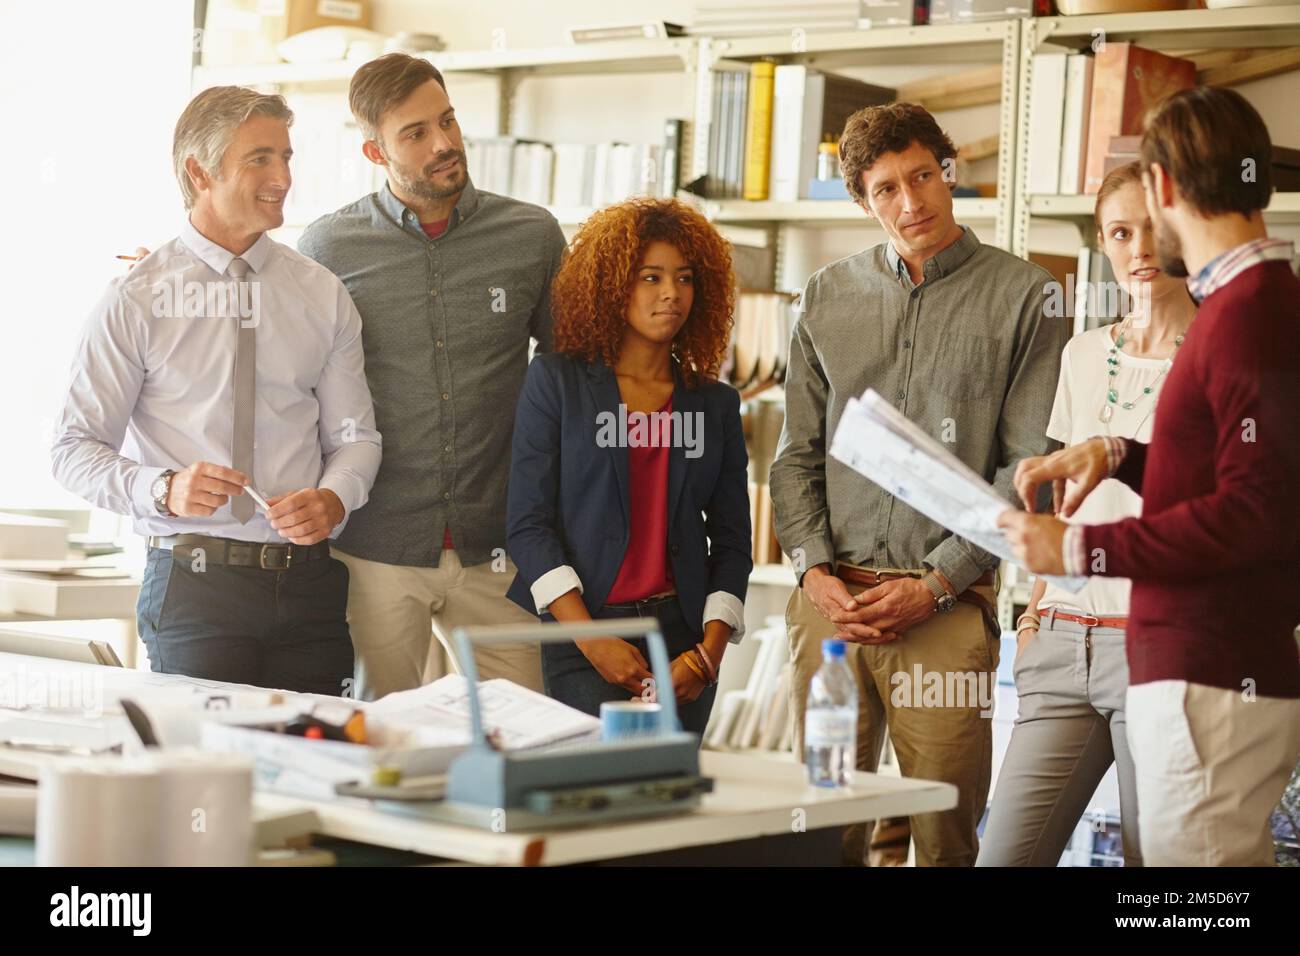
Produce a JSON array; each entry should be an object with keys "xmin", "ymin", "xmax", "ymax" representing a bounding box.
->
[{"xmin": 333, "ymin": 550, "xmax": 542, "ymax": 700}]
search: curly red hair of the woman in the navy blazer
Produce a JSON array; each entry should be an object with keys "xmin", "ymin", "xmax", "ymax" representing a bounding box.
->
[{"xmin": 551, "ymin": 199, "xmax": 736, "ymax": 389}]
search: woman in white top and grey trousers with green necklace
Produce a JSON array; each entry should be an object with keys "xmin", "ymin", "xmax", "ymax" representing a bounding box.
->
[{"xmin": 976, "ymin": 163, "xmax": 1196, "ymax": 866}]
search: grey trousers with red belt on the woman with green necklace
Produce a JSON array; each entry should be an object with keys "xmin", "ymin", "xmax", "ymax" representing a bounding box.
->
[{"xmin": 976, "ymin": 615, "xmax": 1141, "ymax": 866}]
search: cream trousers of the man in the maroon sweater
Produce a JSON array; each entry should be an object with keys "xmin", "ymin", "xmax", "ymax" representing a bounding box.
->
[{"xmin": 1127, "ymin": 680, "xmax": 1300, "ymax": 866}]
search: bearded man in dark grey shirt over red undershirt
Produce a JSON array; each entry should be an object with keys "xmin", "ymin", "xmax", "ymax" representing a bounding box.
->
[{"xmin": 299, "ymin": 53, "xmax": 564, "ymax": 698}]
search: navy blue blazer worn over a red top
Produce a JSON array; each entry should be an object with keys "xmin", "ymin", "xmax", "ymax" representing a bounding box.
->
[{"xmin": 506, "ymin": 352, "xmax": 754, "ymax": 637}]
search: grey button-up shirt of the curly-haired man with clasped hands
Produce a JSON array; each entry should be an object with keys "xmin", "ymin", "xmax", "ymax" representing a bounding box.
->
[{"xmin": 769, "ymin": 228, "xmax": 1067, "ymax": 592}]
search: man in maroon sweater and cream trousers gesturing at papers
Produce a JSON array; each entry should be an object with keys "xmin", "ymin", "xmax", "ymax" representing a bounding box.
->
[{"xmin": 1000, "ymin": 87, "xmax": 1300, "ymax": 866}]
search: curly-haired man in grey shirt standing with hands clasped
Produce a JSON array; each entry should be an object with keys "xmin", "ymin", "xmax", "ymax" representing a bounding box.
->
[{"xmin": 770, "ymin": 103, "xmax": 1067, "ymax": 866}]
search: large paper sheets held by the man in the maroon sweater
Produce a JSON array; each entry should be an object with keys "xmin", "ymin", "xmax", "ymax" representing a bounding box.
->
[{"xmin": 831, "ymin": 389, "xmax": 1088, "ymax": 592}]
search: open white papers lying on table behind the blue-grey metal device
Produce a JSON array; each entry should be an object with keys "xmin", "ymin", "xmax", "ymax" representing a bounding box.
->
[{"xmin": 365, "ymin": 674, "xmax": 601, "ymax": 750}]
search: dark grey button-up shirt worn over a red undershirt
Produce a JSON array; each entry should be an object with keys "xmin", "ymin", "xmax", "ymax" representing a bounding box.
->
[{"xmin": 298, "ymin": 183, "xmax": 564, "ymax": 567}]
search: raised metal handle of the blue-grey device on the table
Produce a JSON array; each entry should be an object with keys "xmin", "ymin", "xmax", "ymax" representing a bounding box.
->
[{"xmin": 451, "ymin": 618, "xmax": 677, "ymax": 747}]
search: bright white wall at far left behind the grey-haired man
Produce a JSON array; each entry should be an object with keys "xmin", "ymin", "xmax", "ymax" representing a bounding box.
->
[{"xmin": 0, "ymin": 0, "xmax": 191, "ymax": 509}]
